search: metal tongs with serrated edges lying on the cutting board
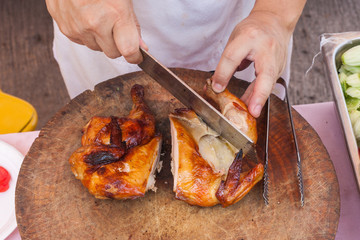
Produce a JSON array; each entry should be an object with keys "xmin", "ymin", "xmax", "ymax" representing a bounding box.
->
[{"xmin": 263, "ymin": 78, "xmax": 305, "ymax": 207}]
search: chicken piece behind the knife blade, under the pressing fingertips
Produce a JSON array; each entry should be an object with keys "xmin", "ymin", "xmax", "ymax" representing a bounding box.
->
[{"xmin": 205, "ymin": 79, "xmax": 257, "ymax": 143}]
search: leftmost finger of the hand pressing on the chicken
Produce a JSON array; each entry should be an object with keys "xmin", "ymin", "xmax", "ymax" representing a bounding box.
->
[{"xmin": 212, "ymin": 35, "xmax": 251, "ymax": 92}]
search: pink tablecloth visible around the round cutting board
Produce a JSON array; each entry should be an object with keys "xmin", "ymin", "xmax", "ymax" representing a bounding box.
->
[{"xmin": 0, "ymin": 102, "xmax": 360, "ymax": 240}]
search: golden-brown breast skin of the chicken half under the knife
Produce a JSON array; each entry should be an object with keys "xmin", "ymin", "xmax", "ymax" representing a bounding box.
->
[{"xmin": 170, "ymin": 109, "xmax": 222, "ymax": 207}]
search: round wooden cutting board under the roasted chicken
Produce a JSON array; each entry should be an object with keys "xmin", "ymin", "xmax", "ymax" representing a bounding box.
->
[{"xmin": 15, "ymin": 69, "xmax": 340, "ymax": 239}]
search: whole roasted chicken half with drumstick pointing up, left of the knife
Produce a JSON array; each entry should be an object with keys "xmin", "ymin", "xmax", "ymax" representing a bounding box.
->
[{"xmin": 69, "ymin": 85, "xmax": 161, "ymax": 199}]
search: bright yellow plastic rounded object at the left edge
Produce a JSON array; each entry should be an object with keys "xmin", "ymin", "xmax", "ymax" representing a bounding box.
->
[{"xmin": 0, "ymin": 90, "xmax": 38, "ymax": 134}]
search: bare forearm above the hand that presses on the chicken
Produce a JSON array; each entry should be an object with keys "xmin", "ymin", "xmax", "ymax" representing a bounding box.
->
[{"xmin": 250, "ymin": 0, "xmax": 306, "ymax": 34}]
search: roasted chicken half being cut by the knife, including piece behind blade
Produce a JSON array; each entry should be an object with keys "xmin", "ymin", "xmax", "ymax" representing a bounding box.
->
[{"xmin": 170, "ymin": 81, "xmax": 264, "ymax": 207}]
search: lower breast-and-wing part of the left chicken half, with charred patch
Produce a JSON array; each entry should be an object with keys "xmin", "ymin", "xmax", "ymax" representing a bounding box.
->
[{"xmin": 70, "ymin": 136, "xmax": 161, "ymax": 199}]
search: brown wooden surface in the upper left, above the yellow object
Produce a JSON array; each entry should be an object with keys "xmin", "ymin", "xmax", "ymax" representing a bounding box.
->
[{"xmin": 0, "ymin": 0, "xmax": 70, "ymax": 129}]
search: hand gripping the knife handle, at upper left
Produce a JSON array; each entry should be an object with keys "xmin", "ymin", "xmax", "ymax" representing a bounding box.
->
[{"xmin": 46, "ymin": 0, "xmax": 148, "ymax": 64}]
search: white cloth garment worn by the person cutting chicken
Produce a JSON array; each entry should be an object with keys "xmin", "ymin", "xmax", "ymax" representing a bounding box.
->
[{"xmin": 53, "ymin": 0, "xmax": 292, "ymax": 98}]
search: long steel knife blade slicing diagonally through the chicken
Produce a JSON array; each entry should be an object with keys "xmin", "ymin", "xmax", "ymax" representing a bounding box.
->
[{"xmin": 139, "ymin": 48, "xmax": 254, "ymax": 155}]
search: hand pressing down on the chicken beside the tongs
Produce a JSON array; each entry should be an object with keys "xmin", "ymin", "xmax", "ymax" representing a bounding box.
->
[{"xmin": 212, "ymin": 11, "xmax": 292, "ymax": 117}]
